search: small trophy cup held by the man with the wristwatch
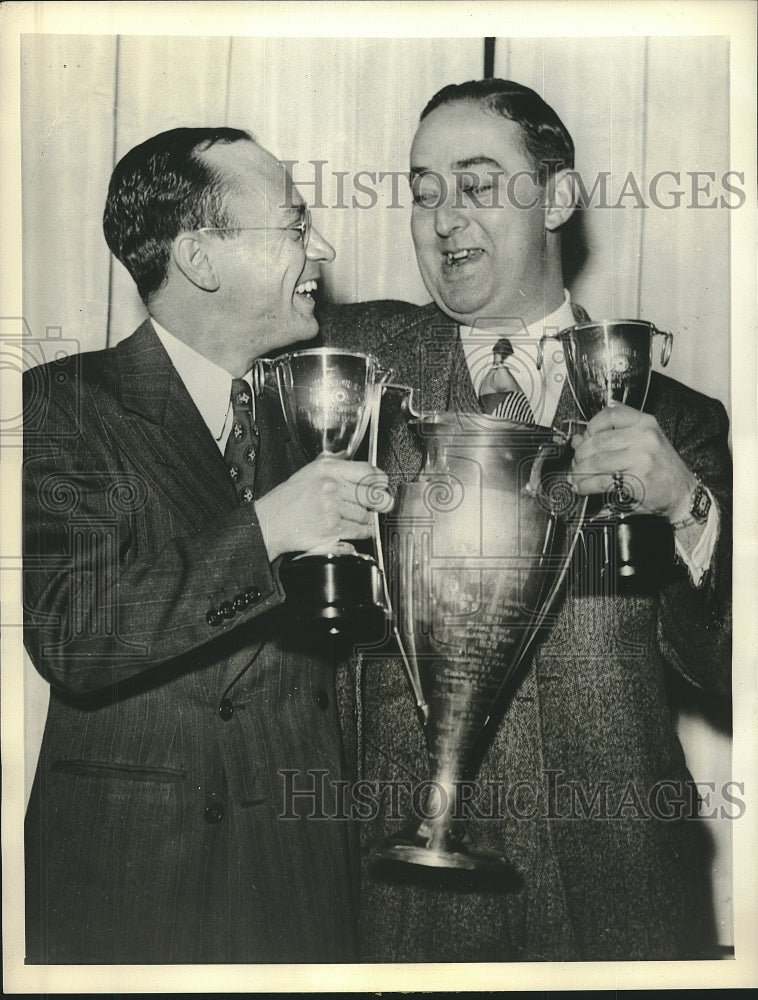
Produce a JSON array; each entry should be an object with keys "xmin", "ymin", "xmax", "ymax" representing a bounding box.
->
[{"xmin": 538, "ymin": 320, "xmax": 675, "ymax": 590}]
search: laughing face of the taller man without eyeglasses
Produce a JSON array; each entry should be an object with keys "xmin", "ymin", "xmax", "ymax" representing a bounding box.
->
[{"xmin": 411, "ymin": 102, "xmax": 571, "ymax": 324}]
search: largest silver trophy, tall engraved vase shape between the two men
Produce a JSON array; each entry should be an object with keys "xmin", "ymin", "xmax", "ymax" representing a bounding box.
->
[{"xmin": 372, "ymin": 410, "xmax": 584, "ymax": 874}]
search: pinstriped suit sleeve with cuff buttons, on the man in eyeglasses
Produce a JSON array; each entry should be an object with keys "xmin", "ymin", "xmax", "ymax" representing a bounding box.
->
[{"xmin": 23, "ymin": 376, "xmax": 284, "ymax": 693}]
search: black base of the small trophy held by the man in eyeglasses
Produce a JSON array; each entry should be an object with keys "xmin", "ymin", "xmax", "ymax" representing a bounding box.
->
[{"xmin": 279, "ymin": 553, "xmax": 388, "ymax": 638}]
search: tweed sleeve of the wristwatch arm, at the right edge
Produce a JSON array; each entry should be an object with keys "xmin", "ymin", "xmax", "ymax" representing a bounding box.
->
[{"xmin": 657, "ymin": 382, "xmax": 732, "ymax": 694}]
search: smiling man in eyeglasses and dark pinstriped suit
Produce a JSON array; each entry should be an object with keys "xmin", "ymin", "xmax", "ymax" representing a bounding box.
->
[{"xmin": 24, "ymin": 128, "xmax": 386, "ymax": 964}]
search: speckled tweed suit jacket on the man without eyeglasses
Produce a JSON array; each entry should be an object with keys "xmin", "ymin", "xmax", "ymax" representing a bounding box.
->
[{"xmin": 320, "ymin": 301, "xmax": 731, "ymax": 961}]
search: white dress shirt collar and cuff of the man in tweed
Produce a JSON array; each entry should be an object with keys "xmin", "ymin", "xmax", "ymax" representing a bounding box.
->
[{"xmin": 460, "ymin": 291, "xmax": 719, "ymax": 586}]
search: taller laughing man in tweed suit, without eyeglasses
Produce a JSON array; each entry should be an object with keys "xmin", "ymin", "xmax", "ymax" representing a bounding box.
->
[{"xmin": 321, "ymin": 80, "xmax": 731, "ymax": 962}]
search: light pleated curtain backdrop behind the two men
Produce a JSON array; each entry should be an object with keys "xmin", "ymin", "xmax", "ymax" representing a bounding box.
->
[{"xmin": 21, "ymin": 34, "xmax": 732, "ymax": 944}]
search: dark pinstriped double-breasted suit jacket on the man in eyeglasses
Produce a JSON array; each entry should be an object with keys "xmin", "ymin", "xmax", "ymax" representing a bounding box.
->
[{"xmin": 24, "ymin": 322, "xmax": 355, "ymax": 964}]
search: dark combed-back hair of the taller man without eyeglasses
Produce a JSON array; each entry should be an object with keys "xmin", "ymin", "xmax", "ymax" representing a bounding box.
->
[{"xmin": 421, "ymin": 78, "xmax": 574, "ymax": 184}]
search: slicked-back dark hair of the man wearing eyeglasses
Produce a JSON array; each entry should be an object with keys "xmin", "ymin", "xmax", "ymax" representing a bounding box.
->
[{"xmin": 103, "ymin": 127, "xmax": 255, "ymax": 305}]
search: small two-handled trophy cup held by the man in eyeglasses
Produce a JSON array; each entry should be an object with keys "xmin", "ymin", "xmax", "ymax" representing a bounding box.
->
[{"xmin": 265, "ymin": 347, "xmax": 390, "ymax": 633}]
